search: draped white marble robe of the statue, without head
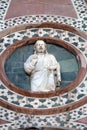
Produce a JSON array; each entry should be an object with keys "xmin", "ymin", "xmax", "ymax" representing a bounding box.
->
[{"xmin": 24, "ymin": 53, "xmax": 61, "ymax": 92}]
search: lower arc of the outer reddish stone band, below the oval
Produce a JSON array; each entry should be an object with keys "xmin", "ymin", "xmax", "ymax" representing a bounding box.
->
[{"xmin": 0, "ymin": 97, "xmax": 87, "ymax": 115}]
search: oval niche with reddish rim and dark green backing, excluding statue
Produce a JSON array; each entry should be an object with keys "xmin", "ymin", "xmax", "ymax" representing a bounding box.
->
[{"xmin": 0, "ymin": 37, "xmax": 86, "ymax": 97}]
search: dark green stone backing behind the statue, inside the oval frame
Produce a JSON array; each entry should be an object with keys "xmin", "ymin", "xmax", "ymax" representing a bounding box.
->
[{"xmin": 5, "ymin": 40, "xmax": 79, "ymax": 90}]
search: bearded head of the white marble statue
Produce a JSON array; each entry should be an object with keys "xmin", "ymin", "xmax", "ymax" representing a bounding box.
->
[{"xmin": 34, "ymin": 40, "xmax": 46, "ymax": 53}]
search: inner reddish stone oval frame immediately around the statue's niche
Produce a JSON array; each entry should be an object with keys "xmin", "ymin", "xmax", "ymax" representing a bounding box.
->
[{"xmin": 0, "ymin": 37, "xmax": 86, "ymax": 98}]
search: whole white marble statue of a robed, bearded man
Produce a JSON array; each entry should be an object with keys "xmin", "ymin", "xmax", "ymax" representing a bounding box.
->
[{"xmin": 24, "ymin": 40, "xmax": 61, "ymax": 92}]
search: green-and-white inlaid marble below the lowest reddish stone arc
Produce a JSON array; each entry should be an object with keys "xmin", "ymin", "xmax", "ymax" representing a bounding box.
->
[{"xmin": 0, "ymin": 104, "xmax": 87, "ymax": 130}]
